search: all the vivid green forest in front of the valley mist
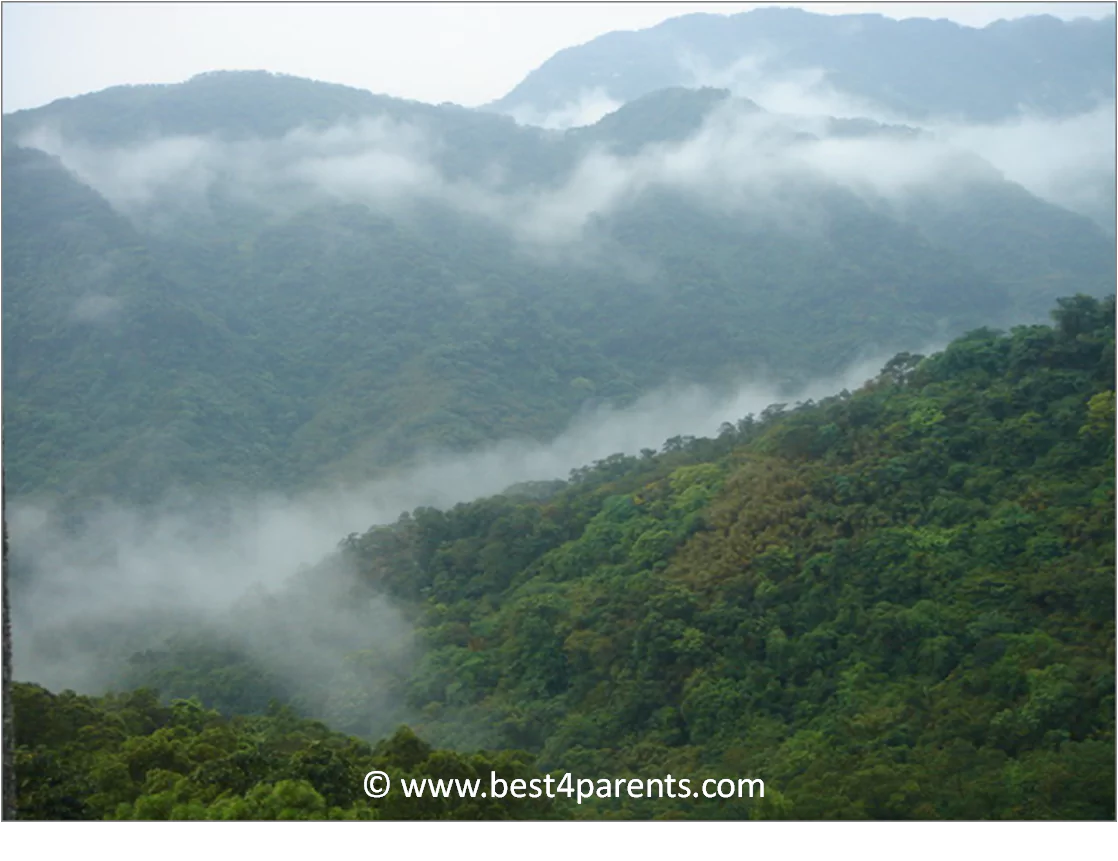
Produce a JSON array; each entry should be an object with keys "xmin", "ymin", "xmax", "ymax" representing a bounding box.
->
[{"xmin": 16, "ymin": 295, "xmax": 1115, "ymax": 820}]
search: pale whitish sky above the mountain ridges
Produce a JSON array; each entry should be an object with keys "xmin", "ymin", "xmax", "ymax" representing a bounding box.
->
[{"xmin": 2, "ymin": 0, "xmax": 1115, "ymax": 112}]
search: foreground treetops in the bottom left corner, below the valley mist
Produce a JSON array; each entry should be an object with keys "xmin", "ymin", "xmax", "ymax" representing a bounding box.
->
[{"xmin": 15, "ymin": 683, "xmax": 555, "ymax": 820}]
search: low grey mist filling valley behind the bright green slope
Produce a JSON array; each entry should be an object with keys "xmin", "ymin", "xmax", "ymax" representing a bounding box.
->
[{"xmin": 8, "ymin": 342, "xmax": 925, "ymax": 736}]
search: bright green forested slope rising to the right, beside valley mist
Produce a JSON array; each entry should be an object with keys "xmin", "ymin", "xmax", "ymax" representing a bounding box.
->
[{"xmin": 328, "ymin": 297, "xmax": 1115, "ymax": 819}]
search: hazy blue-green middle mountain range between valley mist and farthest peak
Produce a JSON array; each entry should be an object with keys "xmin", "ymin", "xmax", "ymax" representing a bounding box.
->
[{"xmin": 3, "ymin": 73, "xmax": 1115, "ymax": 505}]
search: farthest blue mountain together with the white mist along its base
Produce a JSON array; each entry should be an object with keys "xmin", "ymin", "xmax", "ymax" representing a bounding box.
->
[{"xmin": 486, "ymin": 7, "xmax": 1118, "ymax": 235}]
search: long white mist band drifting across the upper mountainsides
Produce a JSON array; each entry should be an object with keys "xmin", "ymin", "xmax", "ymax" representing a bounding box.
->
[{"xmin": 21, "ymin": 81, "xmax": 1100, "ymax": 263}]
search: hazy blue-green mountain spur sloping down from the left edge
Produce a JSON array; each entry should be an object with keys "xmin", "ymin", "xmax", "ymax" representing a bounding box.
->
[{"xmin": 3, "ymin": 148, "xmax": 301, "ymax": 500}]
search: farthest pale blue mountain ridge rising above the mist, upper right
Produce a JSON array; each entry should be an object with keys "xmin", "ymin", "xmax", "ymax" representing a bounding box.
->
[{"xmin": 487, "ymin": 7, "xmax": 1116, "ymax": 123}]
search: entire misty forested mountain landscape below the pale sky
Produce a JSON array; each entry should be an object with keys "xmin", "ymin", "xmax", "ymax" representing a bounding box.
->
[{"xmin": 2, "ymin": 7, "xmax": 1118, "ymax": 821}]
